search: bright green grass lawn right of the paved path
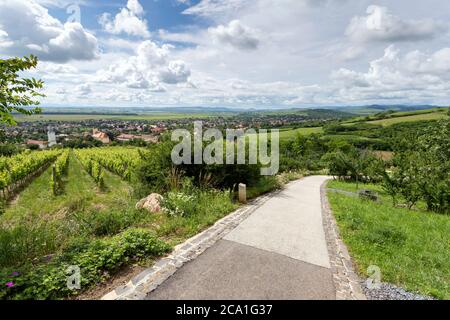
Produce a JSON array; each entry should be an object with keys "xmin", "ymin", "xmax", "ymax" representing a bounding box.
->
[{"xmin": 328, "ymin": 181, "xmax": 450, "ymax": 299}]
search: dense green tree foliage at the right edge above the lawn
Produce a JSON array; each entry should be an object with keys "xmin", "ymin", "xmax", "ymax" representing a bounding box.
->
[{"xmin": 383, "ymin": 120, "xmax": 450, "ymax": 213}]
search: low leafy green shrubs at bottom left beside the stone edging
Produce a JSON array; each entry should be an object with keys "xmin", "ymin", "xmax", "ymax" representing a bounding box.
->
[{"xmin": 0, "ymin": 229, "xmax": 170, "ymax": 299}]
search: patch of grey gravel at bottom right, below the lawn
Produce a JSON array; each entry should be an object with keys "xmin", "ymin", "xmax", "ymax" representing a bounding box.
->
[{"xmin": 362, "ymin": 282, "xmax": 435, "ymax": 300}]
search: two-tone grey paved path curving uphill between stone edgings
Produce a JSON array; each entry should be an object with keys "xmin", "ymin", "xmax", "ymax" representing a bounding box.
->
[{"xmin": 147, "ymin": 176, "xmax": 336, "ymax": 300}]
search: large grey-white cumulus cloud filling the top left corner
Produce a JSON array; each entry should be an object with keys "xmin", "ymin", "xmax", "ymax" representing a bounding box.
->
[{"xmin": 0, "ymin": 0, "xmax": 98, "ymax": 62}]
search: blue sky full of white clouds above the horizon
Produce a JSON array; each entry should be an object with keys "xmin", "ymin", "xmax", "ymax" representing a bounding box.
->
[{"xmin": 0, "ymin": 0, "xmax": 450, "ymax": 108}]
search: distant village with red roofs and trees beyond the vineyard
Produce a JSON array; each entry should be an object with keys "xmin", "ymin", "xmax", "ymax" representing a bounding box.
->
[{"xmin": 0, "ymin": 110, "xmax": 348, "ymax": 149}]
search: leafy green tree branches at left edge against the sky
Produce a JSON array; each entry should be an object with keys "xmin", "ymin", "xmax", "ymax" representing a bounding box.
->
[{"xmin": 0, "ymin": 55, "xmax": 44, "ymax": 124}]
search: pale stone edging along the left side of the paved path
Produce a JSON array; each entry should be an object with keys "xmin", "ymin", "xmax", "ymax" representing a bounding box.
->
[{"xmin": 102, "ymin": 191, "xmax": 279, "ymax": 300}]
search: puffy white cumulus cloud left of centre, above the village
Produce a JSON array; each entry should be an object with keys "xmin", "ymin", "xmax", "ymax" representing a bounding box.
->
[{"xmin": 97, "ymin": 40, "xmax": 191, "ymax": 92}]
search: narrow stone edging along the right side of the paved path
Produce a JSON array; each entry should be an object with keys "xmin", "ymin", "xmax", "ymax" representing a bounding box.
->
[{"xmin": 320, "ymin": 181, "xmax": 367, "ymax": 300}]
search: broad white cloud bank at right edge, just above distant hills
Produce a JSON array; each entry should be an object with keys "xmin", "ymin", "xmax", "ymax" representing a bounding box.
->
[{"xmin": 331, "ymin": 45, "xmax": 450, "ymax": 101}]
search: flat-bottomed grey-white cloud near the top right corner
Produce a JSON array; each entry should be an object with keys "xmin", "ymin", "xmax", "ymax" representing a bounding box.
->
[{"xmin": 346, "ymin": 5, "xmax": 448, "ymax": 42}]
